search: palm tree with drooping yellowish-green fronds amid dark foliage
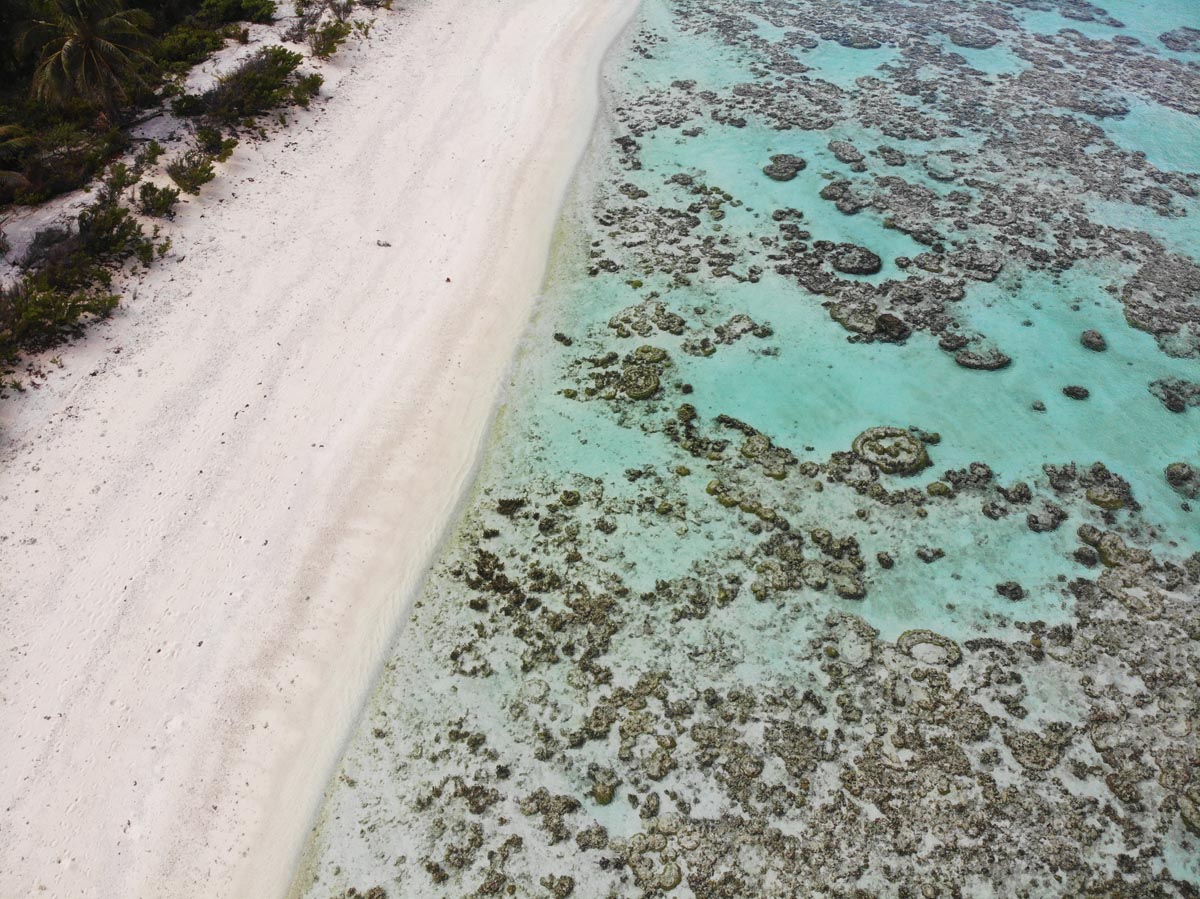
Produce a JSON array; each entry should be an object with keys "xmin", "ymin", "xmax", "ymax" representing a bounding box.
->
[{"xmin": 26, "ymin": 0, "xmax": 152, "ymax": 119}]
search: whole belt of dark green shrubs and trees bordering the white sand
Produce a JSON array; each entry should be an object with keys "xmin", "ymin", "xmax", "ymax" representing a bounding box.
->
[{"xmin": 0, "ymin": 0, "xmax": 364, "ymax": 381}]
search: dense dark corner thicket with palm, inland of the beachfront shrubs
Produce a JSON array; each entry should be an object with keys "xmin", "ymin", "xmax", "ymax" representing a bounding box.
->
[{"xmin": 0, "ymin": 0, "xmax": 290, "ymax": 208}]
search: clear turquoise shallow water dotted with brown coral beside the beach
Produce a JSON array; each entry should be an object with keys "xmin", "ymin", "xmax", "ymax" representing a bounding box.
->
[{"xmin": 301, "ymin": 0, "xmax": 1200, "ymax": 897}]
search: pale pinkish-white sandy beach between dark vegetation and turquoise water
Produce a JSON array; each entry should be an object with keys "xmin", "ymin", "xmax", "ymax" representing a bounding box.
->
[{"xmin": 0, "ymin": 0, "xmax": 636, "ymax": 897}]
